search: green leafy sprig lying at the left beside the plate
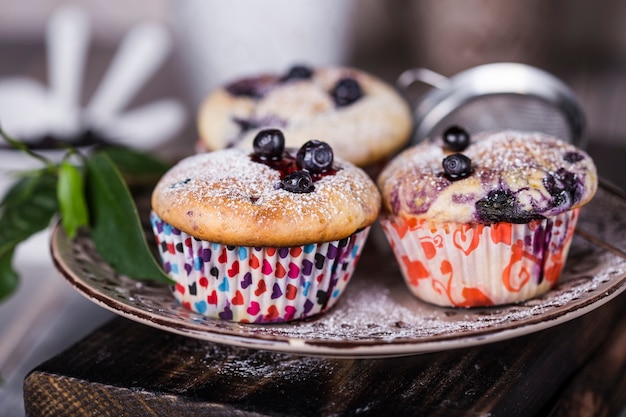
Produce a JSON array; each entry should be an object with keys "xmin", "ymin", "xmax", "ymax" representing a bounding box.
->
[{"xmin": 0, "ymin": 128, "xmax": 171, "ymax": 301}]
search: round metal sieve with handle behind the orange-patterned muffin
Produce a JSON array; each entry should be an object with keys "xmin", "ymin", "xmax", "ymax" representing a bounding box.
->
[{"xmin": 397, "ymin": 63, "xmax": 586, "ymax": 148}]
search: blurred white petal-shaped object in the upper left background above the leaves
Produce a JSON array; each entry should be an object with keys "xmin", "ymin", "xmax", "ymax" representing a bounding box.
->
[{"xmin": 0, "ymin": 6, "xmax": 187, "ymax": 150}]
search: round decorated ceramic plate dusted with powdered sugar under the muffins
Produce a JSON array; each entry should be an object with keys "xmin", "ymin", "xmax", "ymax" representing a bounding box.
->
[{"xmin": 51, "ymin": 184, "xmax": 626, "ymax": 358}]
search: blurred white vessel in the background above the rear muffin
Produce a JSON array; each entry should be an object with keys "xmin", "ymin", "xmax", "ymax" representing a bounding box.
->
[{"xmin": 172, "ymin": 0, "xmax": 355, "ymax": 106}]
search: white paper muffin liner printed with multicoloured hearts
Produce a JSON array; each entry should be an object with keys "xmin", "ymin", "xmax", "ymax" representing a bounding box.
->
[{"xmin": 150, "ymin": 212, "xmax": 369, "ymax": 323}]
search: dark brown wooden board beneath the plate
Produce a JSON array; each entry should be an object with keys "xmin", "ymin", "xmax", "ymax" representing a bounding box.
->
[{"xmin": 24, "ymin": 294, "xmax": 626, "ymax": 416}]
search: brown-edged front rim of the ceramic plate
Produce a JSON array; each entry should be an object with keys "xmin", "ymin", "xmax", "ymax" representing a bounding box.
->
[{"xmin": 50, "ymin": 224, "xmax": 626, "ymax": 358}]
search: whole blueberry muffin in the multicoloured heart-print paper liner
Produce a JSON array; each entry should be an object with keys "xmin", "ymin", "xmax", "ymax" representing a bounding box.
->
[{"xmin": 151, "ymin": 129, "xmax": 380, "ymax": 323}]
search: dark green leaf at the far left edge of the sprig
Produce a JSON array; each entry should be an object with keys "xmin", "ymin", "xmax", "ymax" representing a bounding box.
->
[{"xmin": 0, "ymin": 169, "xmax": 58, "ymax": 300}]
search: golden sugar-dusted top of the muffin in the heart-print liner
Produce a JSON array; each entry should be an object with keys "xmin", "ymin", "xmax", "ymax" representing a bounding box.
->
[{"xmin": 152, "ymin": 133, "xmax": 380, "ymax": 247}]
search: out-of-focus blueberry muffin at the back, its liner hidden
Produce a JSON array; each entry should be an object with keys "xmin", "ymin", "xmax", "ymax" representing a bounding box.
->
[{"xmin": 197, "ymin": 66, "xmax": 412, "ymax": 166}]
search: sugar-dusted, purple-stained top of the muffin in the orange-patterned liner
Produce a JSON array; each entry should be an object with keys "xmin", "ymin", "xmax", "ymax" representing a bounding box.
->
[{"xmin": 378, "ymin": 128, "xmax": 598, "ymax": 224}]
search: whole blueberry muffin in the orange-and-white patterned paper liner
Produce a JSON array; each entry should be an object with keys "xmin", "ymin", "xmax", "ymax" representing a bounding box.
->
[{"xmin": 378, "ymin": 127, "xmax": 597, "ymax": 307}]
